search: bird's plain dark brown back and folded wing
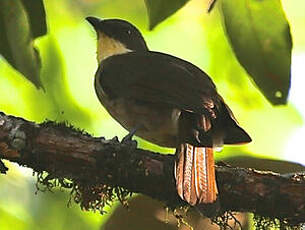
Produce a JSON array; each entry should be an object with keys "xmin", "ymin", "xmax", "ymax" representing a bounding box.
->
[{"xmin": 97, "ymin": 52, "xmax": 218, "ymax": 114}]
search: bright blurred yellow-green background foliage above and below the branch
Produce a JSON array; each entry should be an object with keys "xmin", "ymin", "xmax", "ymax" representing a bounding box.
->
[{"xmin": 0, "ymin": 0, "xmax": 305, "ymax": 230}]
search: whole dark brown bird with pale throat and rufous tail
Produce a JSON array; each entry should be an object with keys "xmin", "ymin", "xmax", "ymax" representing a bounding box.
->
[{"xmin": 87, "ymin": 17, "xmax": 251, "ymax": 205}]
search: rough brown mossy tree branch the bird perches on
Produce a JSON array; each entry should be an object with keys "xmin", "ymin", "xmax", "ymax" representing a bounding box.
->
[{"xmin": 0, "ymin": 113, "xmax": 305, "ymax": 224}]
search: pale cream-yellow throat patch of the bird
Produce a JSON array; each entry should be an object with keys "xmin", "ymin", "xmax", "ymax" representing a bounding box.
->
[{"xmin": 97, "ymin": 33, "xmax": 132, "ymax": 63}]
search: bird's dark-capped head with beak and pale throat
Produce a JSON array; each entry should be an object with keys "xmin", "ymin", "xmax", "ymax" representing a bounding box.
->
[{"xmin": 86, "ymin": 17, "xmax": 148, "ymax": 63}]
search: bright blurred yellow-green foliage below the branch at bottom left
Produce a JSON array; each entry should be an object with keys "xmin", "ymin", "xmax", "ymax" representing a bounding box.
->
[{"xmin": 0, "ymin": 164, "xmax": 107, "ymax": 230}]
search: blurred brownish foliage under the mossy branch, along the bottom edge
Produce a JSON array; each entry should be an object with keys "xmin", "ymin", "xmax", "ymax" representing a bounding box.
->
[{"xmin": 102, "ymin": 195, "xmax": 248, "ymax": 230}]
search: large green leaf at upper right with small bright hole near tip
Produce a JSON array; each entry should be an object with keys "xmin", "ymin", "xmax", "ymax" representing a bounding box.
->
[{"xmin": 221, "ymin": 0, "xmax": 292, "ymax": 105}]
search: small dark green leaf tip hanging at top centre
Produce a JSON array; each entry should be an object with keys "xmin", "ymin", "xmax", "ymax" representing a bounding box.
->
[{"xmin": 145, "ymin": 0, "xmax": 189, "ymax": 30}]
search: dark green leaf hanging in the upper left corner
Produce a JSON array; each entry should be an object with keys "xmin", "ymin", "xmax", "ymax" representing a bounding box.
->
[{"xmin": 0, "ymin": 0, "xmax": 46, "ymax": 88}]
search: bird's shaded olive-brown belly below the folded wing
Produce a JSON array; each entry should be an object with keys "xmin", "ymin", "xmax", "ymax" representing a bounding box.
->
[{"xmin": 98, "ymin": 90, "xmax": 181, "ymax": 147}]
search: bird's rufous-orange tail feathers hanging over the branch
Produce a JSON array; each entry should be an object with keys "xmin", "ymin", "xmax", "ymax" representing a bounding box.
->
[{"xmin": 175, "ymin": 144, "xmax": 218, "ymax": 205}]
